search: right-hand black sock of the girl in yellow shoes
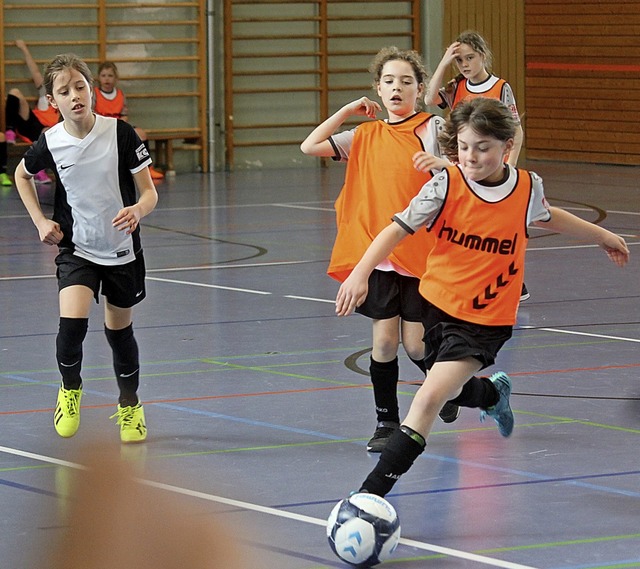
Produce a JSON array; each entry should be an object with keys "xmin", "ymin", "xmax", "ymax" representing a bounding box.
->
[{"xmin": 104, "ymin": 324, "xmax": 140, "ymax": 407}]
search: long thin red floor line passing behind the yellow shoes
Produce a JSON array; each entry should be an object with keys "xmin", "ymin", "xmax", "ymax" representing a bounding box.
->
[{"xmin": 0, "ymin": 363, "xmax": 640, "ymax": 416}]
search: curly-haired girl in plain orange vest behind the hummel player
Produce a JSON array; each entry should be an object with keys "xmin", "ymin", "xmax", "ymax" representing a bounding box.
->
[{"xmin": 301, "ymin": 47, "xmax": 458, "ymax": 452}]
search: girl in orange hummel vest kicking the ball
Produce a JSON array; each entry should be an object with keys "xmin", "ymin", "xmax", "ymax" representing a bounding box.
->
[{"xmin": 336, "ymin": 98, "xmax": 629, "ymax": 496}]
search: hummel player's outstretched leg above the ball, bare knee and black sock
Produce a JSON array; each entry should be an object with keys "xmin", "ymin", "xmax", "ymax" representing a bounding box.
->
[{"xmin": 360, "ymin": 358, "xmax": 481, "ymax": 496}]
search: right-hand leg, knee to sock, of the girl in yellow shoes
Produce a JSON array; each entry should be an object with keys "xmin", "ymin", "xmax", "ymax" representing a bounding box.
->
[{"xmin": 104, "ymin": 301, "xmax": 140, "ymax": 407}]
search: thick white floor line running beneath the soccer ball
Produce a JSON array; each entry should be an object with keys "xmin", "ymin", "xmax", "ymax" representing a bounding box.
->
[{"xmin": 0, "ymin": 446, "xmax": 537, "ymax": 569}]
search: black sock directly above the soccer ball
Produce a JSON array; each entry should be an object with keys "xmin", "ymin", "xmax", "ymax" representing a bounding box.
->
[{"xmin": 360, "ymin": 425, "xmax": 426, "ymax": 496}]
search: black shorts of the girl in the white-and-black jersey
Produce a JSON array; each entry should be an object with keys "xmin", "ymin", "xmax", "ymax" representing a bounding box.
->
[{"xmin": 56, "ymin": 249, "xmax": 147, "ymax": 308}]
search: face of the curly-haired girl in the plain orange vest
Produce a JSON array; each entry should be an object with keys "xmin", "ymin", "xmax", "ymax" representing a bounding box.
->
[{"xmin": 378, "ymin": 59, "xmax": 424, "ymax": 119}]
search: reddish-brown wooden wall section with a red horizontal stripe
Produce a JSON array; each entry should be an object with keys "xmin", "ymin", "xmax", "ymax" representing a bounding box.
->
[{"xmin": 525, "ymin": 0, "xmax": 640, "ymax": 164}]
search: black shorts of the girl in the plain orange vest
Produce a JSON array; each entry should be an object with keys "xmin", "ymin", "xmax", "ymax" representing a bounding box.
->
[{"xmin": 356, "ymin": 269, "xmax": 423, "ymax": 322}]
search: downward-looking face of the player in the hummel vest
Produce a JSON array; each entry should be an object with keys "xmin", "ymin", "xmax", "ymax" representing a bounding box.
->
[{"xmin": 458, "ymin": 126, "xmax": 513, "ymax": 182}]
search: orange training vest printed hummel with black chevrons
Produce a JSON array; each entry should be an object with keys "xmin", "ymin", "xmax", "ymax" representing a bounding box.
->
[{"xmin": 420, "ymin": 166, "xmax": 532, "ymax": 326}]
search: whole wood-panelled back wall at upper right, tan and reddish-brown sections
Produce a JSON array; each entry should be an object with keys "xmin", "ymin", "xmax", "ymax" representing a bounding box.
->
[{"xmin": 440, "ymin": 0, "xmax": 640, "ymax": 165}]
